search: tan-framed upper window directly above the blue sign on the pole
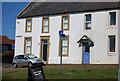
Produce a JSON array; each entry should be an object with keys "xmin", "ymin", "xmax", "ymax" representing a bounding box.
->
[{"xmin": 62, "ymin": 15, "xmax": 69, "ymax": 30}]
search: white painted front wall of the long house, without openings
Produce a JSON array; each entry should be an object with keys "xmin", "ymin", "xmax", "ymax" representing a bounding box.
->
[{"xmin": 15, "ymin": 10, "xmax": 118, "ymax": 64}]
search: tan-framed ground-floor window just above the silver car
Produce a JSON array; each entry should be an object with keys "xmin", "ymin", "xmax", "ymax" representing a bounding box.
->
[{"xmin": 24, "ymin": 37, "xmax": 32, "ymax": 54}]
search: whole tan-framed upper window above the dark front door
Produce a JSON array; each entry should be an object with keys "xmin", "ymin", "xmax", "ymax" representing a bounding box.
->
[{"xmin": 42, "ymin": 17, "xmax": 49, "ymax": 33}]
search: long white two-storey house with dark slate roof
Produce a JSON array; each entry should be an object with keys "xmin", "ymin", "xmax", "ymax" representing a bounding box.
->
[{"xmin": 15, "ymin": 2, "xmax": 120, "ymax": 64}]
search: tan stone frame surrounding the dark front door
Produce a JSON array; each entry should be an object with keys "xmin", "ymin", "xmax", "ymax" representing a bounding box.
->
[{"xmin": 40, "ymin": 36, "xmax": 50, "ymax": 63}]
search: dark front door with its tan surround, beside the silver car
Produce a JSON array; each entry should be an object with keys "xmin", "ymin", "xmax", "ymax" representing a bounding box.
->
[{"xmin": 40, "ymin": 37, "xmax": 49, "ymax": 63}]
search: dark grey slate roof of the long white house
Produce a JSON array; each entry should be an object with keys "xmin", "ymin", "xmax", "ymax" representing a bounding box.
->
[{"xmin": 17, "ymin": 2, "xmax": 120, "ymax": 18}]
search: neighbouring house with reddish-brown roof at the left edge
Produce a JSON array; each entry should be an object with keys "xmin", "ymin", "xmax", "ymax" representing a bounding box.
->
[{"xmin": 0, "ymin": 35, "xmax": 15, "ymax": 54}]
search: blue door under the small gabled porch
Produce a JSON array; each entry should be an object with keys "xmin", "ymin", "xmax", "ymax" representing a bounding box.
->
[{"xmin": 82, "ymin": 43, "xmax": 90, "ymax": 64}]
